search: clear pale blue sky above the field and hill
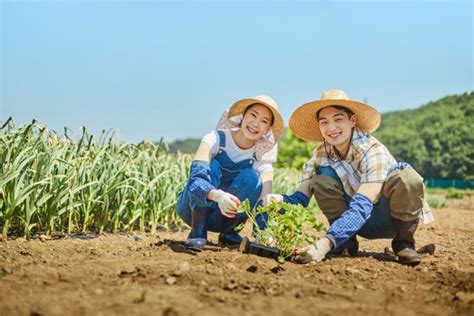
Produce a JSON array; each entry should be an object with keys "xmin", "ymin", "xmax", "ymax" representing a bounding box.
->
[{"xmin": 0, "ymin": 0, "xmax": 474, "ymax": 142}]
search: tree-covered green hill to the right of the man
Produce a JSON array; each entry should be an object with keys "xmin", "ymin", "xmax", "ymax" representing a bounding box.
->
[{"xmin": 374, "ymin": 92, "xmax": 474, "ymax": 179}]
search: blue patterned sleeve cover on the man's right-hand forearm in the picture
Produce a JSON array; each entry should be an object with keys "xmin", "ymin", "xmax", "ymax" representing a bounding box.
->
[{"xmin": 326, "ymin": 193, "xmax": 374, "ymax": 248}]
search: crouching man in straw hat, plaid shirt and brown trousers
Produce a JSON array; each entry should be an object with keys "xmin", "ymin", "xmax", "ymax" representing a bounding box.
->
[{"xmin": 263, "ymin": 90, "xmax": 429, "ymax": 265}]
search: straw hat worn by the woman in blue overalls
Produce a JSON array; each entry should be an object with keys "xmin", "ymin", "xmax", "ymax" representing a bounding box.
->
[{"xmin": 228, "ymin": 95, "xmax": 283, "ymax": 139}]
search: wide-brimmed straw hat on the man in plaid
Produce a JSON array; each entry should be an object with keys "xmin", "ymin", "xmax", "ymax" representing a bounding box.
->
[{"xmin": 289, "ymin": 90, "xmax": 381, "ymax": 141}]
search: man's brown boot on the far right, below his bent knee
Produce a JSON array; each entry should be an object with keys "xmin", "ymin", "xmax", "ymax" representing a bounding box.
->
[{"xmin": 392, "ymin": 217, "xmax": 421, "ymax": 265}]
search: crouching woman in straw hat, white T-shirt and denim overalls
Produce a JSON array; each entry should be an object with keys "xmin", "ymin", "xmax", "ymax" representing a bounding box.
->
[{"xmin": 177, "ymin": 95, "xmax": 283, "ymax": 251}]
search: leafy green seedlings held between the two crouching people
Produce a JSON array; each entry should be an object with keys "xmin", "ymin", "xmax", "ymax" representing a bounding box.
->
[{"xmin": 239, "ymin": 200, "xmax": 324, "ymax": 262}]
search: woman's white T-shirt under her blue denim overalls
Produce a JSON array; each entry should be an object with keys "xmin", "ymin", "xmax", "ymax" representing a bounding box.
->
[{"xmin": 201, "ymin": 130, "xmax": 273, "ymax": 176}]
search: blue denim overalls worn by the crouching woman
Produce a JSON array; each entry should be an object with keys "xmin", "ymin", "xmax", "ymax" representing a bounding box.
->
[{"xmin": 177, "ymin": 131, "xmax": 262, "ymax": 233}]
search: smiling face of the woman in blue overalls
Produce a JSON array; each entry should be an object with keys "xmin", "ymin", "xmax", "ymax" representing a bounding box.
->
[{"xmin": 241, "ymin": 104, "xmax": 273, "ymax": 141}]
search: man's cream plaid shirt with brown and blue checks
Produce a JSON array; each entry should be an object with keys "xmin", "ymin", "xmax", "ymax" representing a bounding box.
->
[{"xmin": 301, "ymin": 128, "xmax": 396, "ymax": 196}]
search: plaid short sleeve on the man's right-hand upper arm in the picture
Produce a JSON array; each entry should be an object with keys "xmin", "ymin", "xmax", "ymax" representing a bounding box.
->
[{"xmin": 360, "ymin": 144, "xmax": 393, "ymax": 183}]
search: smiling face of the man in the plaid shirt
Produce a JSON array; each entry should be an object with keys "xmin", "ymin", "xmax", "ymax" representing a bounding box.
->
[{"xmin": 318, "ymin": 106, "xmax": 356, "ymax": 149}]
